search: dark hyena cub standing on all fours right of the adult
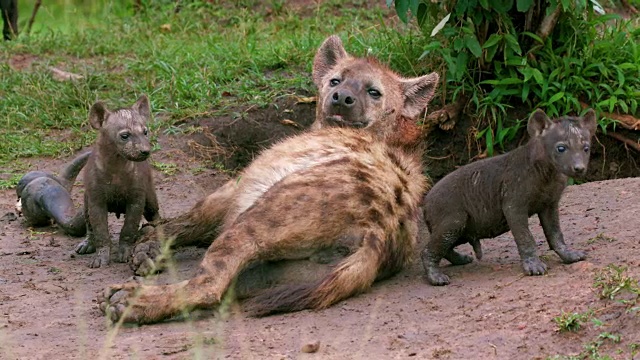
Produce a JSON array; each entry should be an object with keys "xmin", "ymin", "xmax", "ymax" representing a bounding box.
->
[{"xmin": 422, "ymin": 109, "xmax": 596, "ymax": 285}]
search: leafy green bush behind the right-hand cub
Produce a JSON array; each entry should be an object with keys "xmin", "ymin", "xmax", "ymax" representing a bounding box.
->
[{"xmin": 387, "ymin": 0, "xmax": 640, "ymax": 155}]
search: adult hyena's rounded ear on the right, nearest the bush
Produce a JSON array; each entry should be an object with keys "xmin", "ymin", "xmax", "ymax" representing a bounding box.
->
[{"xmin": 401, "ymin": 72, "xmax": 440, "ymax": 119}]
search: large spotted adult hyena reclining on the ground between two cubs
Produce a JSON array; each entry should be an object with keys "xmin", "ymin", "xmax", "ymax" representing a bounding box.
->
[{"xmin": 100, "ymin": 36, "xmax": 438, "ymax": 323}]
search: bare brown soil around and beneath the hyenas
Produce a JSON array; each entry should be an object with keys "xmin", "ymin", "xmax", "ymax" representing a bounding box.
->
[{"xmin": 0, "ymin": 98, "xmax": 640, "ymax": 360}]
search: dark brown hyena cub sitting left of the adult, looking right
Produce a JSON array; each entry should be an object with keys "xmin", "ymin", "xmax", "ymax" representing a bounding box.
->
[{"xmin": 76, "ymin": 95, "xmax": 159, "ymax": 268}]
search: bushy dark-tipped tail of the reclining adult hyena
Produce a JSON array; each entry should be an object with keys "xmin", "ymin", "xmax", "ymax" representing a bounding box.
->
[{"xmin": 244, "ymin": 240, "xmax": 381, "ymax": 317}]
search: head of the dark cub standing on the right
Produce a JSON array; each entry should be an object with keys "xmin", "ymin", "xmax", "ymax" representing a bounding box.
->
[{"xmin": 527, "ymin": 109, "xmax": 597, "ymax": 177}]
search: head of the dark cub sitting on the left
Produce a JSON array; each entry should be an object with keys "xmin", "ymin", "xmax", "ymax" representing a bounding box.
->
[{"xmin": 89, "ymin": 95, "xmax": 151, "ymax": 161}]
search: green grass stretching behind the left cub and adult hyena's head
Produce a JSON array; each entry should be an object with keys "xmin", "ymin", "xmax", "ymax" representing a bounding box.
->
[{"xmin": 0, "ymin": 0, "xmax": 430, "ymax": 180}]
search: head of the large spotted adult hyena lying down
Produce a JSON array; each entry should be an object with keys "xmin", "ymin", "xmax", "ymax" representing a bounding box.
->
[{"xmin": 312, "ymin": 35, "xmax": 439, "ymax": 144}]
